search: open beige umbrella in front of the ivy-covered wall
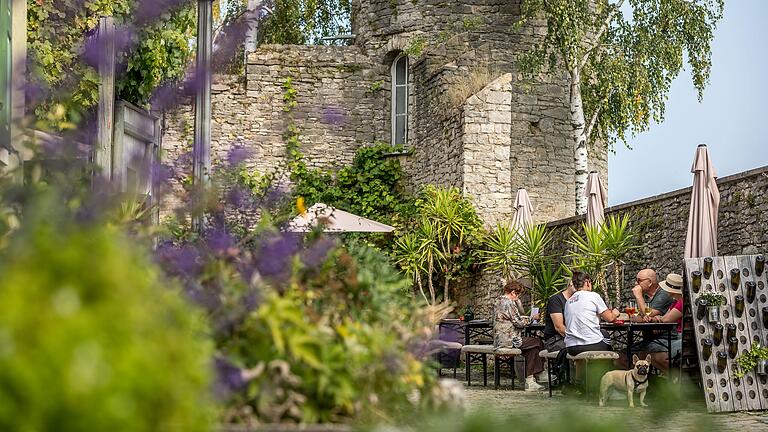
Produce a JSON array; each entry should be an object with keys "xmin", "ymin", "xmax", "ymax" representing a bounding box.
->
[{"xmin": 286, "ymin": 203, "xmax": 395, "ymax": 232}]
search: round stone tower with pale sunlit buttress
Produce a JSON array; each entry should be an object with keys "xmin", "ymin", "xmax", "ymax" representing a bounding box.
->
[{"xmin": 352, "ymin": 0, "xmax": 607, "ymax": 223}]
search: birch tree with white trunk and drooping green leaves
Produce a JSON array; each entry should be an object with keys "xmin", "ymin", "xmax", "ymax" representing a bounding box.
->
[{"xmin": 519, "ymin": 0, "xmax": 723, "ymax": 214}]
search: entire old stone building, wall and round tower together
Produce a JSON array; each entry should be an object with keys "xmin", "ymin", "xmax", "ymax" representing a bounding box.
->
[{"xmin": 163, "ymin": 0, "xmax": 607, "ymax": 224}]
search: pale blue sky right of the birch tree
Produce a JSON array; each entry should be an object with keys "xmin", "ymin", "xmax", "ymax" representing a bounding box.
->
[{"xmin": 608, "ymin": 0, "xmax": 768, "ymax": 205}]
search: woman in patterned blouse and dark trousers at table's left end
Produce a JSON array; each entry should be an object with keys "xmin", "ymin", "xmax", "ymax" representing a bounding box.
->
[{"xmin": 493, "ymin": 280, "xmax": 544, "ymax": 391}]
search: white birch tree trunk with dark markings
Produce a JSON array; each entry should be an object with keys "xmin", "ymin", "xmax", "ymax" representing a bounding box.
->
[{"xmin": 570, "ymin": 68, "xmax": 589, "ymax": 214}]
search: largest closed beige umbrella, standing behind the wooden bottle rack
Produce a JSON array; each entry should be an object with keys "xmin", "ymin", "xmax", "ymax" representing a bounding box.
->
[{"xmin": 685, "ymin": 144, "xmax": 720, "ymax": 258}]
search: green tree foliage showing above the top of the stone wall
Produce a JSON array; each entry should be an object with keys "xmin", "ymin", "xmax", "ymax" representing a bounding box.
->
[{"xmin": 262, "ymin": 0, "xmax": 352, "ymax": 45}]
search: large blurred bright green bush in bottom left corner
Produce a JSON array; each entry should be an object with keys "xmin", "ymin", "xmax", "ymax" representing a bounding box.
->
[{"xmin": 0, "ymin": 190, "xmax": 212, "ymax": 431}]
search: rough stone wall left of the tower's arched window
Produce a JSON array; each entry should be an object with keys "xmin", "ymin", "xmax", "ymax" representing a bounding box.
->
[{"xmin": 163, "ymin": 45, "xmax": 390, "ymax": 214}]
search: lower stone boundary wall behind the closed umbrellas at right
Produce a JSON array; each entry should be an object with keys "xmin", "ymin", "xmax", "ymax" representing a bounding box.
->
[{"xmin": 549, "ymin": 166, "xmax": 768, "ymax": 290}]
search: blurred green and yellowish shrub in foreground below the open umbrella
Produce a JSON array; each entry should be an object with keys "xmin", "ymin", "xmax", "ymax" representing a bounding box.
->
[{"xmin": 220, "ymin": 244, "xmax": 444, "ymax": 423}]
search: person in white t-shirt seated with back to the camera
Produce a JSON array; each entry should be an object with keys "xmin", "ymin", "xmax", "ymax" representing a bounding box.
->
[{"xmin": 564, "ymin": 270, "xmax": 619, "ymax": 356}]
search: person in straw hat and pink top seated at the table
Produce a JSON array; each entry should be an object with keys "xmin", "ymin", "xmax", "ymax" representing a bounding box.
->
[{"xmin": 640, "ymin": 273, "xmax": 683, "ymax": 372}]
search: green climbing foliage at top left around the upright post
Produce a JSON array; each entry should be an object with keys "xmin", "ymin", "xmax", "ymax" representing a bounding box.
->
[{"xmin": 27, "ymin": 0, "xmax": 195, "ymax": 129}]
